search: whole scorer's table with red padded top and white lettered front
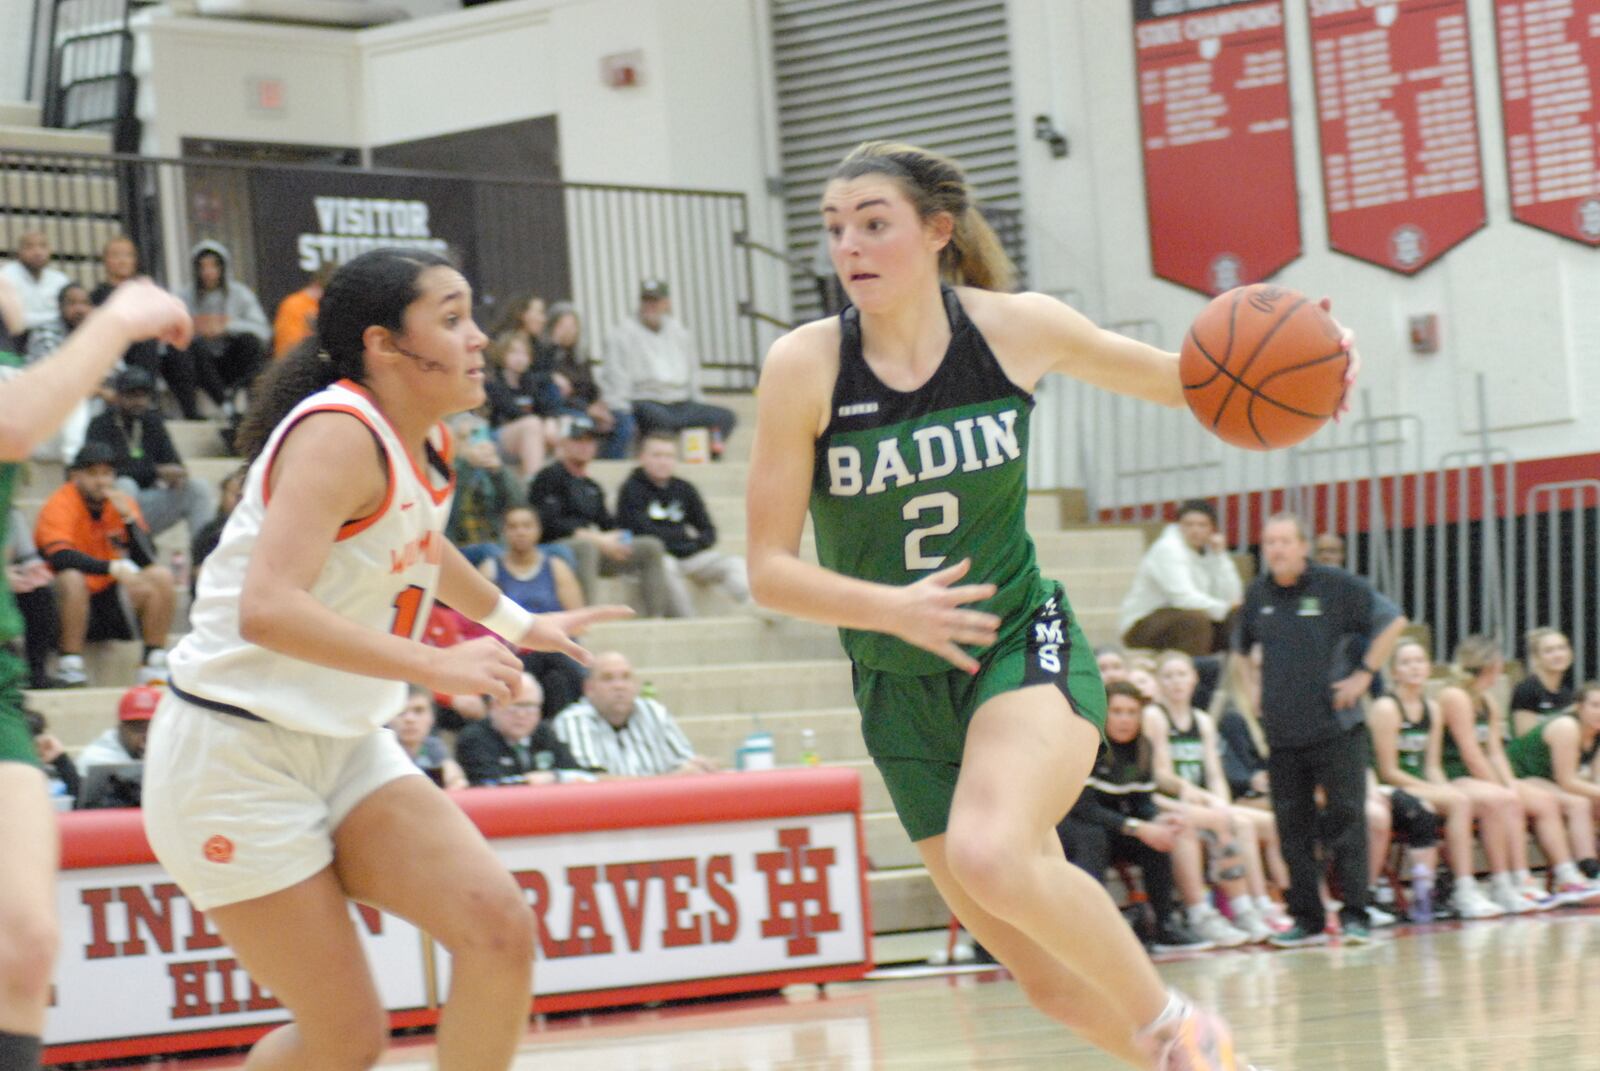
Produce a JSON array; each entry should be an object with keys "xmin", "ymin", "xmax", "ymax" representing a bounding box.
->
[{"xmin": 45, "ymin": 768, "xmax": 872, "ymax": 1065}]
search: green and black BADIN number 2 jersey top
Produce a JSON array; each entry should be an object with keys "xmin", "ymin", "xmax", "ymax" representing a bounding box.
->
[{"xmin": 811, "ymin": 288, "xmax": 1043, "ymax": 676}]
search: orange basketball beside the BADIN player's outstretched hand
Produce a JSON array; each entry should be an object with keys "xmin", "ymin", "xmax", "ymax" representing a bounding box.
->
[{"xmin": 1178, "ymin": 283, "xmax": 1350, "ymax": 450}]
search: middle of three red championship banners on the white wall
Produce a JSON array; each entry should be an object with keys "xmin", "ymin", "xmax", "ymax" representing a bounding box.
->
[{"xmin": 1310, "ymin": 0, "xmax": 1486, "ymax": 275}]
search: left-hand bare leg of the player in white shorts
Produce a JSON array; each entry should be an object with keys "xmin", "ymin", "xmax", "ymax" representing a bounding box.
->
[{"xmin": 206, "ymin": 866, "xmax": 389, "ymax": 1071}]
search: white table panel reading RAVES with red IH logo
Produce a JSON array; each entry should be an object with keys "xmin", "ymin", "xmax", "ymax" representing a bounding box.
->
[{"xmin": 438, "ymin": 815, "xmax": 867, "ymax": 996}]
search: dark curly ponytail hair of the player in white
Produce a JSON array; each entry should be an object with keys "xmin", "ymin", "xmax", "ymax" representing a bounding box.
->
[{"xmin": 238, "ymin": 248, "xmax": 453, "ymax": 461}]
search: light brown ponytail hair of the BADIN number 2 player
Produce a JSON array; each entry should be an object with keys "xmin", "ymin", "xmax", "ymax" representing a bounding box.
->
[{"xmin": 832, "ymin": 141, "xmax": 1016, "ymax": 290}]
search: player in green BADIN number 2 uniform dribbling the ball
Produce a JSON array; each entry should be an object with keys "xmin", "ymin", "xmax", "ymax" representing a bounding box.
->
[{"xmin": 747, "ymin": 142, "xmax": 1354, "ymax": 1071}]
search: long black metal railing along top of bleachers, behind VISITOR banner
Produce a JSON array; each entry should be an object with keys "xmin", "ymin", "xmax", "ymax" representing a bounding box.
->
[{"xmin": 0, "ymin": 150, "xmax": 760, "ymax": 389}]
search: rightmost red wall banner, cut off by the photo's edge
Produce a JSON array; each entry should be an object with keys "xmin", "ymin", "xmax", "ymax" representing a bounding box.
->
[{"xmin": 1494, "ymin": 0, "xmax": 1600, "ymax": 245}]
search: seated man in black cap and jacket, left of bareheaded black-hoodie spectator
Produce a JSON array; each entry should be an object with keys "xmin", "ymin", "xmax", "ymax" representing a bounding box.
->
[{"xmin": 528, "ymin": 416, "xmax": 693, "ymax": 618}]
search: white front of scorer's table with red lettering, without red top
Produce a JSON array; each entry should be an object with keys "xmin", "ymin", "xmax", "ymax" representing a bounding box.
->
[{"xmin": 45, "ymin": 813, "xmax": 869, "ymax": 1045}]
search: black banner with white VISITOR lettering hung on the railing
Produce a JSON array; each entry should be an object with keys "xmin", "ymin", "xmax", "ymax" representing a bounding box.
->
[{"xmin": 250, "ymin": 168, "xmax": 477, "ymax": 311}]
